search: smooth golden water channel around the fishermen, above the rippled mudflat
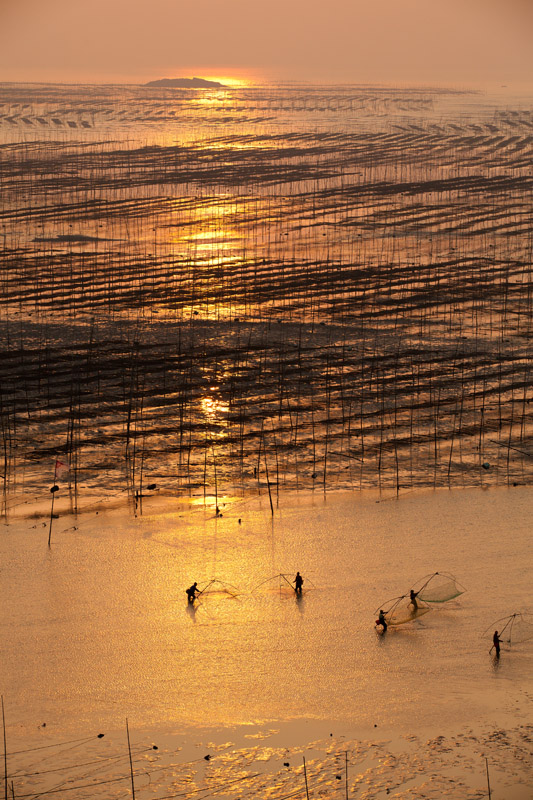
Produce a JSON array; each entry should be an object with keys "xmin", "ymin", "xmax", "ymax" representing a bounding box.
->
[{"xmin": 0, "ymin": 487, "xmax": 533, "ymax": 737}]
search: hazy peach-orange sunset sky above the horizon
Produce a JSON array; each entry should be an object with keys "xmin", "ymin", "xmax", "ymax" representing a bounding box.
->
[{"xmin": 0, "ymin": 0, "xmax": 533, "ymax": 86}]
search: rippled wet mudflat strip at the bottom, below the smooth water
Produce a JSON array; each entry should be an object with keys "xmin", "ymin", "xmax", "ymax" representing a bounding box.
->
[{"xmin": 9, "ymin": 720, "xmax": 533, "ymax": 800}]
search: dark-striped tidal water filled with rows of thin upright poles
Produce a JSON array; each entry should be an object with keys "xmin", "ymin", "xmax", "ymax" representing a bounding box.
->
[{"xmin": 0, "ymin": 83, "xmax": 533, "ymax": 506}]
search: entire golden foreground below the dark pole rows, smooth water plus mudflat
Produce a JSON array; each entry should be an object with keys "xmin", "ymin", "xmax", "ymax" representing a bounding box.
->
[{"xmin": 0, "ymin": 487, "xmax": 533, "ymax": 800}]
